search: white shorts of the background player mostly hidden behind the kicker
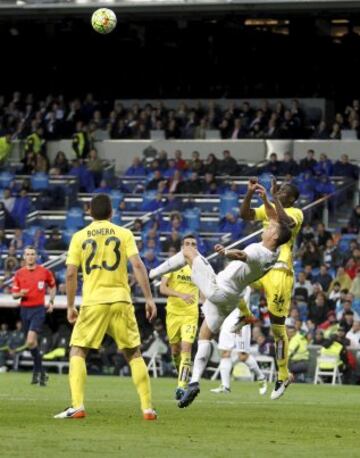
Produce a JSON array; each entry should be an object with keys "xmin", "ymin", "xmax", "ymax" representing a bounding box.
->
[{"xmin": 218, "ymin": 309, "xmax": 251, "ymax": 353}]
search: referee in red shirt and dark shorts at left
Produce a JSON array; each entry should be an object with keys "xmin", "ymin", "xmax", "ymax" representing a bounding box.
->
[{"xmin": 12, "ymin": 246, "xmax": 56, "ymax": 386}]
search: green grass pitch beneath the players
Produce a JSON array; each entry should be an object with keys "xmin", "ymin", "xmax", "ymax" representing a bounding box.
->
[{"xmin": 0, "ymin": 373, "xmax": 360, "ymax": 458}]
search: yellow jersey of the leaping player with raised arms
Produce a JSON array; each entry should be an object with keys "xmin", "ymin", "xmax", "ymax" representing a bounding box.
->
[{"xmin": 254, "ymin": 205, "xmax": 304, "ymax": 271}]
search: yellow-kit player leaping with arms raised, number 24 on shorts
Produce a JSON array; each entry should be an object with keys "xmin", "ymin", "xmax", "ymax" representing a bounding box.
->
[{"xmin": 240, "ymin": 179, "xmax": 304, "ymax": 400}]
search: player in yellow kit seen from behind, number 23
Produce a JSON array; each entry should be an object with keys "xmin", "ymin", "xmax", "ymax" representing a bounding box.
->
[{"xmin": 55, "ymin": 194, "xmax": 157, "ymax": 420}]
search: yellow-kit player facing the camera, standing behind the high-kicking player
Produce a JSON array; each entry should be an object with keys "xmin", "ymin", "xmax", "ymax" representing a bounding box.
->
[{"xmin": 160, "ymin": 235, "xmax": 199, "ymax": 400}]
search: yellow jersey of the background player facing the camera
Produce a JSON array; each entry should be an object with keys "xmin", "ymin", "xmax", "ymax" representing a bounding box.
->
[{"xmin": 164, "ymin": 266, "xmax": 199, "ymax": 317}]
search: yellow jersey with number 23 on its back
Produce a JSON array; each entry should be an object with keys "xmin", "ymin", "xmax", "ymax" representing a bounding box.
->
[{"xmin": 66, "ymin": 220, "xmax": 138, "ymax": 305}]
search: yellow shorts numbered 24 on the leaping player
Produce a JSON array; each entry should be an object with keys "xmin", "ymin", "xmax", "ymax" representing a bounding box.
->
[{"xmin": 251, "ymin": 269, "xmax": 294, "ymax": 317}]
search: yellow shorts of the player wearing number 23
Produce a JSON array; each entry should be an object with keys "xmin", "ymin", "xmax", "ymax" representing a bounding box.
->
[{"xmin": 70, "ymin": 302, "xmax": 140, "ymax": 349}]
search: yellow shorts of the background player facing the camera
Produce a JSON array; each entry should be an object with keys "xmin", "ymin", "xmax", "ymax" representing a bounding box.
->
[{"xmin": 166, "ymin": 313, "xmax": 198, "ymax": 344}]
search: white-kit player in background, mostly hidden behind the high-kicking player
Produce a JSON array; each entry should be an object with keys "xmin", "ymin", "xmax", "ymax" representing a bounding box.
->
[{"xmin": 210, "ymin": 286, "xmax": 267, "ymax": 395}]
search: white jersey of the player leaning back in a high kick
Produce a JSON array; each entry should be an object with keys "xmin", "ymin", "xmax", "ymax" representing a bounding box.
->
[{"xmin": 217, "ymin": 243, "xmax": 280, "ymax": 296}]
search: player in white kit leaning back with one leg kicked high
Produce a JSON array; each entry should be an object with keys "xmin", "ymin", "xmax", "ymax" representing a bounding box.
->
[{"xmin": 149, "ymin": 190, "xmax": 291, "ymax": 408}]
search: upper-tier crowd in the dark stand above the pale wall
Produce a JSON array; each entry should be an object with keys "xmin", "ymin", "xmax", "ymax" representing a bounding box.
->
[{"xmin": 0, "ymin": 92, "xmax": 360, "ymax": 143}]
